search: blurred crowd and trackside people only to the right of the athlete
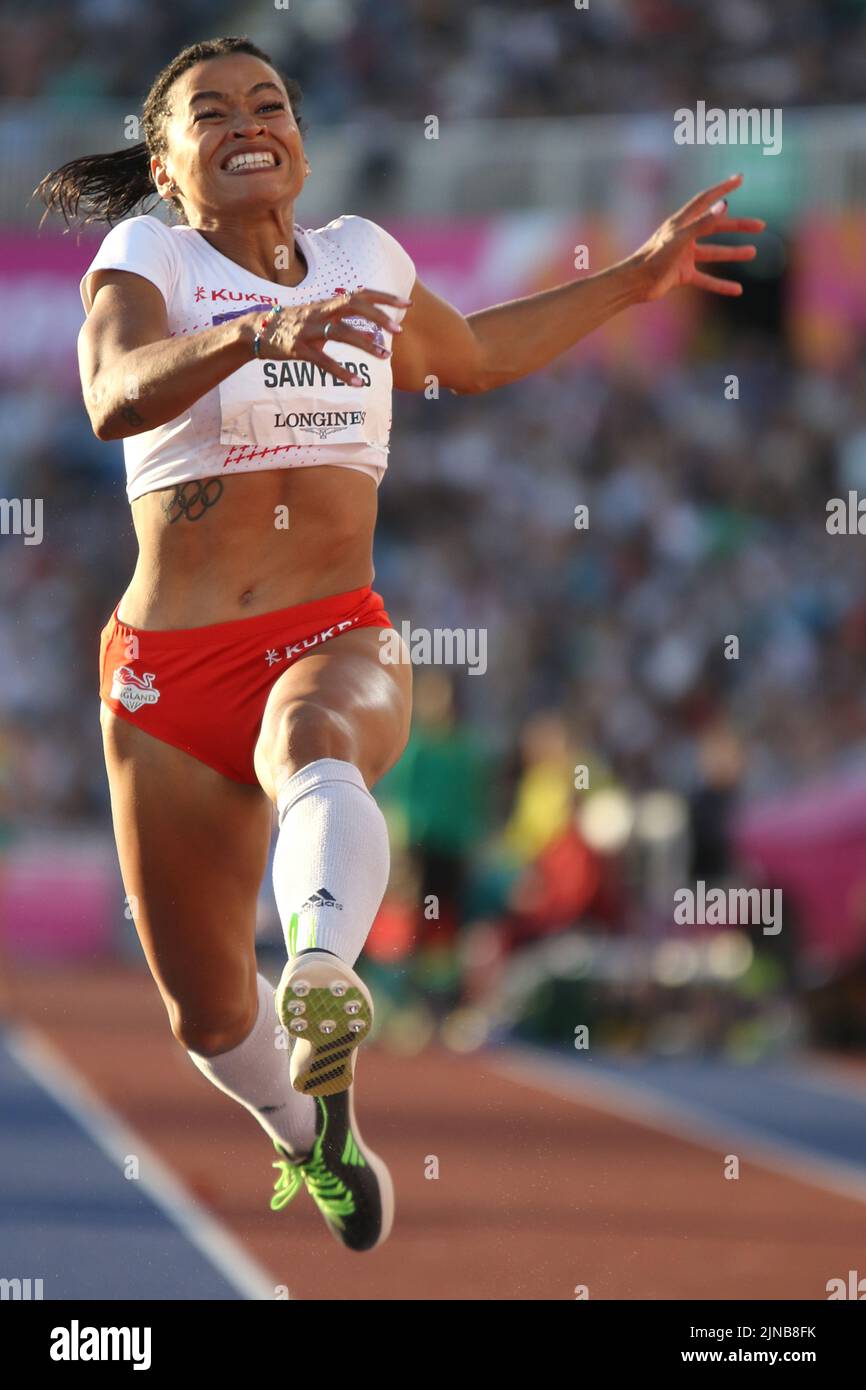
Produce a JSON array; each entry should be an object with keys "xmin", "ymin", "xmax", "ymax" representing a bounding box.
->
[{"xmin": 374, "ymin": 339, "xmax": 866, "ymax": 1052}]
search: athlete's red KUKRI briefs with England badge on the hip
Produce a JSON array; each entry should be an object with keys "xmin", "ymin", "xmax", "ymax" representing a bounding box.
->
[{"xmin": 99, "ymin": 587, "xmax": 392, "ymax": 783}]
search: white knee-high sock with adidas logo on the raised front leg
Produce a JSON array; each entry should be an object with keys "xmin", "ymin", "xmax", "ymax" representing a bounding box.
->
[{"xmin": 274, "ymin": 758, "xmax": 391, "ymax": 965}]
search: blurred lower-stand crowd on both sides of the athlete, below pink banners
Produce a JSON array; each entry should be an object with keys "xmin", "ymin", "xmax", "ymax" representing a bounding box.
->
[{"xmin": 0, "ymin": 284, "xmax": 866, "ymax": 1047}]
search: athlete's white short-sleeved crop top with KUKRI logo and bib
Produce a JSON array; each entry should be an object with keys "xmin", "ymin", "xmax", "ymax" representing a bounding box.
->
[{"xmin": 81, "ymin": 214, "xmax": 416, "ymax": 502}]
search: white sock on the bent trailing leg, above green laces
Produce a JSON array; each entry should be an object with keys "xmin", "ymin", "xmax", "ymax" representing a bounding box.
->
[{"xmin": 189, "ymin": 974, "xmax": 316, "ymax": 1156}]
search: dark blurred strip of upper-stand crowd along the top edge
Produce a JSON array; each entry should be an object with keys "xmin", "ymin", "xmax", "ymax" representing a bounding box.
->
[{"xmin": 0, "ymin": 0, "xmax": 866, "ymax": 122}]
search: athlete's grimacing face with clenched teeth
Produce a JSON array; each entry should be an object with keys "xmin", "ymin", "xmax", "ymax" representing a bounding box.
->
[{"xmin": 152, "ymin": 53, "xmax": 304, "ymax": 222}]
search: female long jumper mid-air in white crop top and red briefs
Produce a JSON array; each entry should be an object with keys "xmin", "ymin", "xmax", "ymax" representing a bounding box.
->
[{"xmin": 39, "ymin": 38, "xmax": 763, "ymax": 1250}]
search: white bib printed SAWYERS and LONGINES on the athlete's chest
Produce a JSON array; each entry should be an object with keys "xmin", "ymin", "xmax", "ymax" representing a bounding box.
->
[{"xmin": 214, "ymin": 304, "xmax": 392, "ymax": 449}]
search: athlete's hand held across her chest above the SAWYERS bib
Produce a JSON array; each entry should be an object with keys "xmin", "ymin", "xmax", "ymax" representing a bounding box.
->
[{"xmin": 259, "ymin": 289, "xmax": 411, "ymax": 386}]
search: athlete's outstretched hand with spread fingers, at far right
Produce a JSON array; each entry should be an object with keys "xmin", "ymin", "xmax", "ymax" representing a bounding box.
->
[{"xmin": 630, "ymin": 174, "xmax": 767, "ymax": 300}]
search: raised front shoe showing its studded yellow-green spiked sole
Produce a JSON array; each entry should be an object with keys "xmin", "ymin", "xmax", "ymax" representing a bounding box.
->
[{"xmin": 275, "ymin": 951, "xmax": 373, "ymax": 1095}]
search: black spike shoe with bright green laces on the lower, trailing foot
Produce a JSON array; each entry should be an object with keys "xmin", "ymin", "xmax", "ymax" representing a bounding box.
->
[{"xmin": 271, "ymin": 1087, "xmax": 393, "ymax": 1251}]
